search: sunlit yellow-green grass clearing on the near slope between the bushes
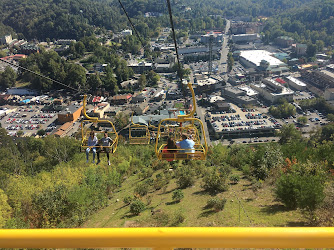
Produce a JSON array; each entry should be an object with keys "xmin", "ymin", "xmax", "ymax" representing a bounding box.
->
[{"xmin": 82, "ymin": 168, "xmax": 306, "ymax": 228}]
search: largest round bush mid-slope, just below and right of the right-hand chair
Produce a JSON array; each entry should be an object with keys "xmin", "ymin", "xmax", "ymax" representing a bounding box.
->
[{"xmin": 202, "ymin": 169, "xmax": 228, "ymax": 194}]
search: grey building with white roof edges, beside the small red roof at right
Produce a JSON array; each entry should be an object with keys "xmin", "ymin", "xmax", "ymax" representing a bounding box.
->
[{"xmin": 251, "ymin": 78, "xmax": 294, "ymax": 103}]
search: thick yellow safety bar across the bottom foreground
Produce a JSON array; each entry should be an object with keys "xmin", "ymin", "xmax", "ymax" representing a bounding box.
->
[{"xmin": 0, "ymin": 227, "xmax": 334, "ymax": 249}]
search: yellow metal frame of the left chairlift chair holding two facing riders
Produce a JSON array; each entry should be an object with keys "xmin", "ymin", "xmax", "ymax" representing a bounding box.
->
[{"xmin": 81, "ymin": 95, "xmax": 118, "ymax": 153}]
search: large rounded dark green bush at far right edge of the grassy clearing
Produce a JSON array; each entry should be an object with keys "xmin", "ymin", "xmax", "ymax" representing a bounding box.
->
[{"xmin": 275, "ymin": 172, "xmax": 325, "ymax": 211}]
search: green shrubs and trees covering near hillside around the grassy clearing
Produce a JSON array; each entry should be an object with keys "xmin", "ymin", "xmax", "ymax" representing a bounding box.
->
[{"xmin": 0, "ymin": 124, "xmax": 334, "ymax": 228}]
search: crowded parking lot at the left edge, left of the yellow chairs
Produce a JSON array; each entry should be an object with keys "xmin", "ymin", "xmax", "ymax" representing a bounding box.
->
[{"xmin": 0, "ymin": 105, "xmax": 57, "ymax": 136}]
